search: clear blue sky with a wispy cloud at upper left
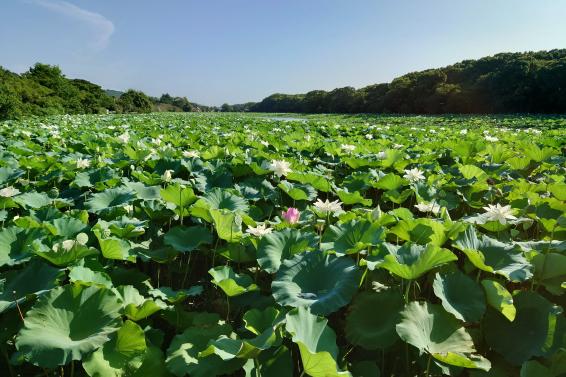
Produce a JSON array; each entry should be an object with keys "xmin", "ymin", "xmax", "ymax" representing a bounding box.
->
[{"xmin": 0, "ymin": 0, "xmax": 566, "ymax": 105}]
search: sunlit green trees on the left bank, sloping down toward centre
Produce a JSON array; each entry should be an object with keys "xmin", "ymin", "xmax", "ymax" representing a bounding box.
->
[{"xmin": 0, "ymin": 63, "xmax": 214, "ymax": 120}]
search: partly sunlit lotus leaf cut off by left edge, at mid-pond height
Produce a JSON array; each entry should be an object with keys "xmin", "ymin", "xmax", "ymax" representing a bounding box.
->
[{"xmin": 0, "ymin": 227, "xmax": 44, "ymax": 267}]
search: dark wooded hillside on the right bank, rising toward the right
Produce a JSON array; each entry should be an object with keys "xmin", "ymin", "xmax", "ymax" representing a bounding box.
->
[{"xmin": 250, "ymin": 50, "xmax": 566, "ymax": 114}]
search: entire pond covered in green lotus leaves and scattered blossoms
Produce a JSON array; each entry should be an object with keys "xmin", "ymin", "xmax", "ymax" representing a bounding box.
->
[{"xmin": 0, "ymin": 114, "xmax": 566, "ymax": 377}]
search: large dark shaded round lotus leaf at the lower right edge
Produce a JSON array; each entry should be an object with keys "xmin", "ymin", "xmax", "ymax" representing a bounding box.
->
[{"xmin": 483, "ymin": 291, "xmax": 566, "ymax": 365}]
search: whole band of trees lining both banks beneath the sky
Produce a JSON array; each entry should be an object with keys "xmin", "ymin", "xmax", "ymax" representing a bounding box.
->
[{"xmin": 0, "ymin": 49, "xmax": 566, "ymax": 120}]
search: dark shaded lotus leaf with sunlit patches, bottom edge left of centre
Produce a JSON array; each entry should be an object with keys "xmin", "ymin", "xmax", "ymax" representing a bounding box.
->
[{"xmin": 165, "ymin": 322, "xmax": 243, "ymax": 377}]
